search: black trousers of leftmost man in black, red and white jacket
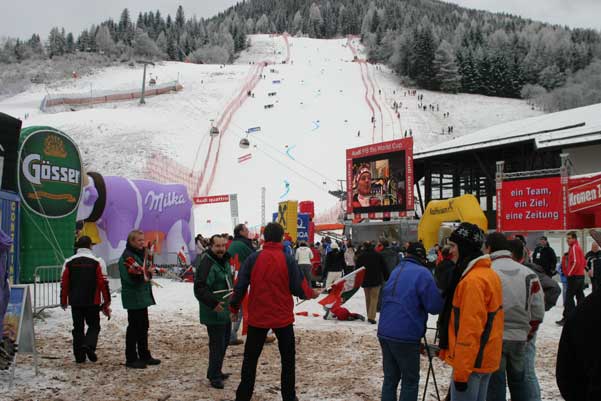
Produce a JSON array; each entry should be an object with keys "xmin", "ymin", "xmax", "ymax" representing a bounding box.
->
[{"xmin": 71, "ymin": 306, "xmax": 100, "ymax": 360}]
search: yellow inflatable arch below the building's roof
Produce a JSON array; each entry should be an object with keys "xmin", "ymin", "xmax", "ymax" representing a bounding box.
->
[{"xmin": 417, "ymin": 194, "xmax": 488, "ymax": 249}]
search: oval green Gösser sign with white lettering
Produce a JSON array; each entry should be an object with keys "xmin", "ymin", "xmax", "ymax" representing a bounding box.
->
[{"xmin": 18, "ymin": 128, "xmax": 83, "ymax": 218}]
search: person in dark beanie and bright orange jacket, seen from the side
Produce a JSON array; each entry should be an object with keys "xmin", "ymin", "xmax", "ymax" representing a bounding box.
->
[{"xmin": 439, "ymin": 223, "xmax": 504, "ymax": 401}]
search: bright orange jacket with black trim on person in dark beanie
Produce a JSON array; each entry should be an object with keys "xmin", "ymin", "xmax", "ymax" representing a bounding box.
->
[{"xmin": 440, "ymin": 255, "xmax": 504, "ymax": 383}]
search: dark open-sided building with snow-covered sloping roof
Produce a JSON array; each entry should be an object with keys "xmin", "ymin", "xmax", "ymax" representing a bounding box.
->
[{"xmin": 414, "ymin": 103, "xmax": 601, "ymax": 228}]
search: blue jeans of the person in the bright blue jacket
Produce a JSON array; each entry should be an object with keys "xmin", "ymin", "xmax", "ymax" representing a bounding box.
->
[{"xmin": 379, "ymin": 338, "xmax": 419, "ymax": 401}]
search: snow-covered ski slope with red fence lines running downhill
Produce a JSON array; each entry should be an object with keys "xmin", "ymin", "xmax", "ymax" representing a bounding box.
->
[{"xmin": 0, "ymin": 35, "xmax": 540, "ymax": 234}]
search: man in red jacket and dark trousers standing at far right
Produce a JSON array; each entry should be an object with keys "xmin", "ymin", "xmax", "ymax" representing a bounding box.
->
[{"xmin": 555, "ymin": 231, "xmax": 586, "ymax": 326}]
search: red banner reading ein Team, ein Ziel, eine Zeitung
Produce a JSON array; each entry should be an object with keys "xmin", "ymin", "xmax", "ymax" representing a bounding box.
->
[{"xmin": 497, "ymin": 177, "xmax": 567, "ymax": 231}]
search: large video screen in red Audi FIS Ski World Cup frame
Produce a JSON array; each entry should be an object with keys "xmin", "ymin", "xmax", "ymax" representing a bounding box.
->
[{"xmin": 346, "ymin": 138, "xmax": 413, "ymax": 218}]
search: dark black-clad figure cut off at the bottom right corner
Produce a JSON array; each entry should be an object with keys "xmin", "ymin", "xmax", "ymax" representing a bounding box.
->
[{"xmin": 555, "ymin": 291, "xmax": 601, "ymax": 401}]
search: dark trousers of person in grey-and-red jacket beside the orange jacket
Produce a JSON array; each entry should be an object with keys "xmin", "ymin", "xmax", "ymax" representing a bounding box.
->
[{"xmin": 486, "ymin": 341, "xmax": 530, "ymax": 401}]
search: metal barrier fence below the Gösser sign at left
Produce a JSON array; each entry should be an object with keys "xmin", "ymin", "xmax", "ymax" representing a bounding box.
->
[{"xmin": 33, "ymin": 266, "xmax": 63, "ymax": 316}]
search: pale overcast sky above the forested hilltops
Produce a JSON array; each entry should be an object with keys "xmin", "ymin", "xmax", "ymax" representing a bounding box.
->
[{"xmin": 0, "ymin": 0, "xmax": 601, "ymax": 38}]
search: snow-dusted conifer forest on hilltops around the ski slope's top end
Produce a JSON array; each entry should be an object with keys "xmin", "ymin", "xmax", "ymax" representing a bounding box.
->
[{"xmin": 0, "ymin": 0, "xmax": 601, "ymax": 111}]
